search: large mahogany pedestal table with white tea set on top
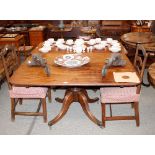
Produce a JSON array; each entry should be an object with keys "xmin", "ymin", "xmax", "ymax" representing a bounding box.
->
[{"xmin": 10, "ymin": 44, "xmax": 137, "ymax": 127}]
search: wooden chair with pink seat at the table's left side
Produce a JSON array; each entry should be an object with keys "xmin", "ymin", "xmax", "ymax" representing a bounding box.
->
[{"xmin": 0, "ymin": 45, "xmax": 48, "ymax": 122}]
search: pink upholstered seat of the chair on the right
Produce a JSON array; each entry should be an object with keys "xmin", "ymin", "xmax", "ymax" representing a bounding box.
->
[{"xmin": 100, "ymin": 87, "xmax": 140, "ymax": 103}]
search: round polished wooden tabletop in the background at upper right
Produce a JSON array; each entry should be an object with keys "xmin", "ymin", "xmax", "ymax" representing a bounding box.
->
[{"xmin": 121, "ymin": 32, "xmax": 155, "ymax": 52}]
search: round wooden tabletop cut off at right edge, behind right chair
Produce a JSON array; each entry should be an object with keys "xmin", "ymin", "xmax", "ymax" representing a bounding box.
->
[{"xmin": 148, "ymin": 63, "xmax": 155, "ymax": 87}]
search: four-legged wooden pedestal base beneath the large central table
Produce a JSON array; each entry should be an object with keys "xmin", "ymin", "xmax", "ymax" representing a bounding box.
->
[{"xmin": 48, "ymin": 88, "xmax": 102, "ymax": 127}]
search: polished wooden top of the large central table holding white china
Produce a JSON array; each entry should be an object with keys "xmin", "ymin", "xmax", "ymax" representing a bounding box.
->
[{"xmin": 10, "ymin": 44, "xmax": 138, "ymax": 86}]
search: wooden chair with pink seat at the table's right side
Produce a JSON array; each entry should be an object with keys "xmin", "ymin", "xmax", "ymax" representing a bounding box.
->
[{"xmin": 100, "ymin": 44, "xmax": 148, "ymax": 127}]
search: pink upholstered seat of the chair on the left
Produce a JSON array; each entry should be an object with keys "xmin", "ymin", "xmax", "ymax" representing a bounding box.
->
[{"xmin": 9, "ymin": 87, "xmax": 48, "ymax": 98}]
